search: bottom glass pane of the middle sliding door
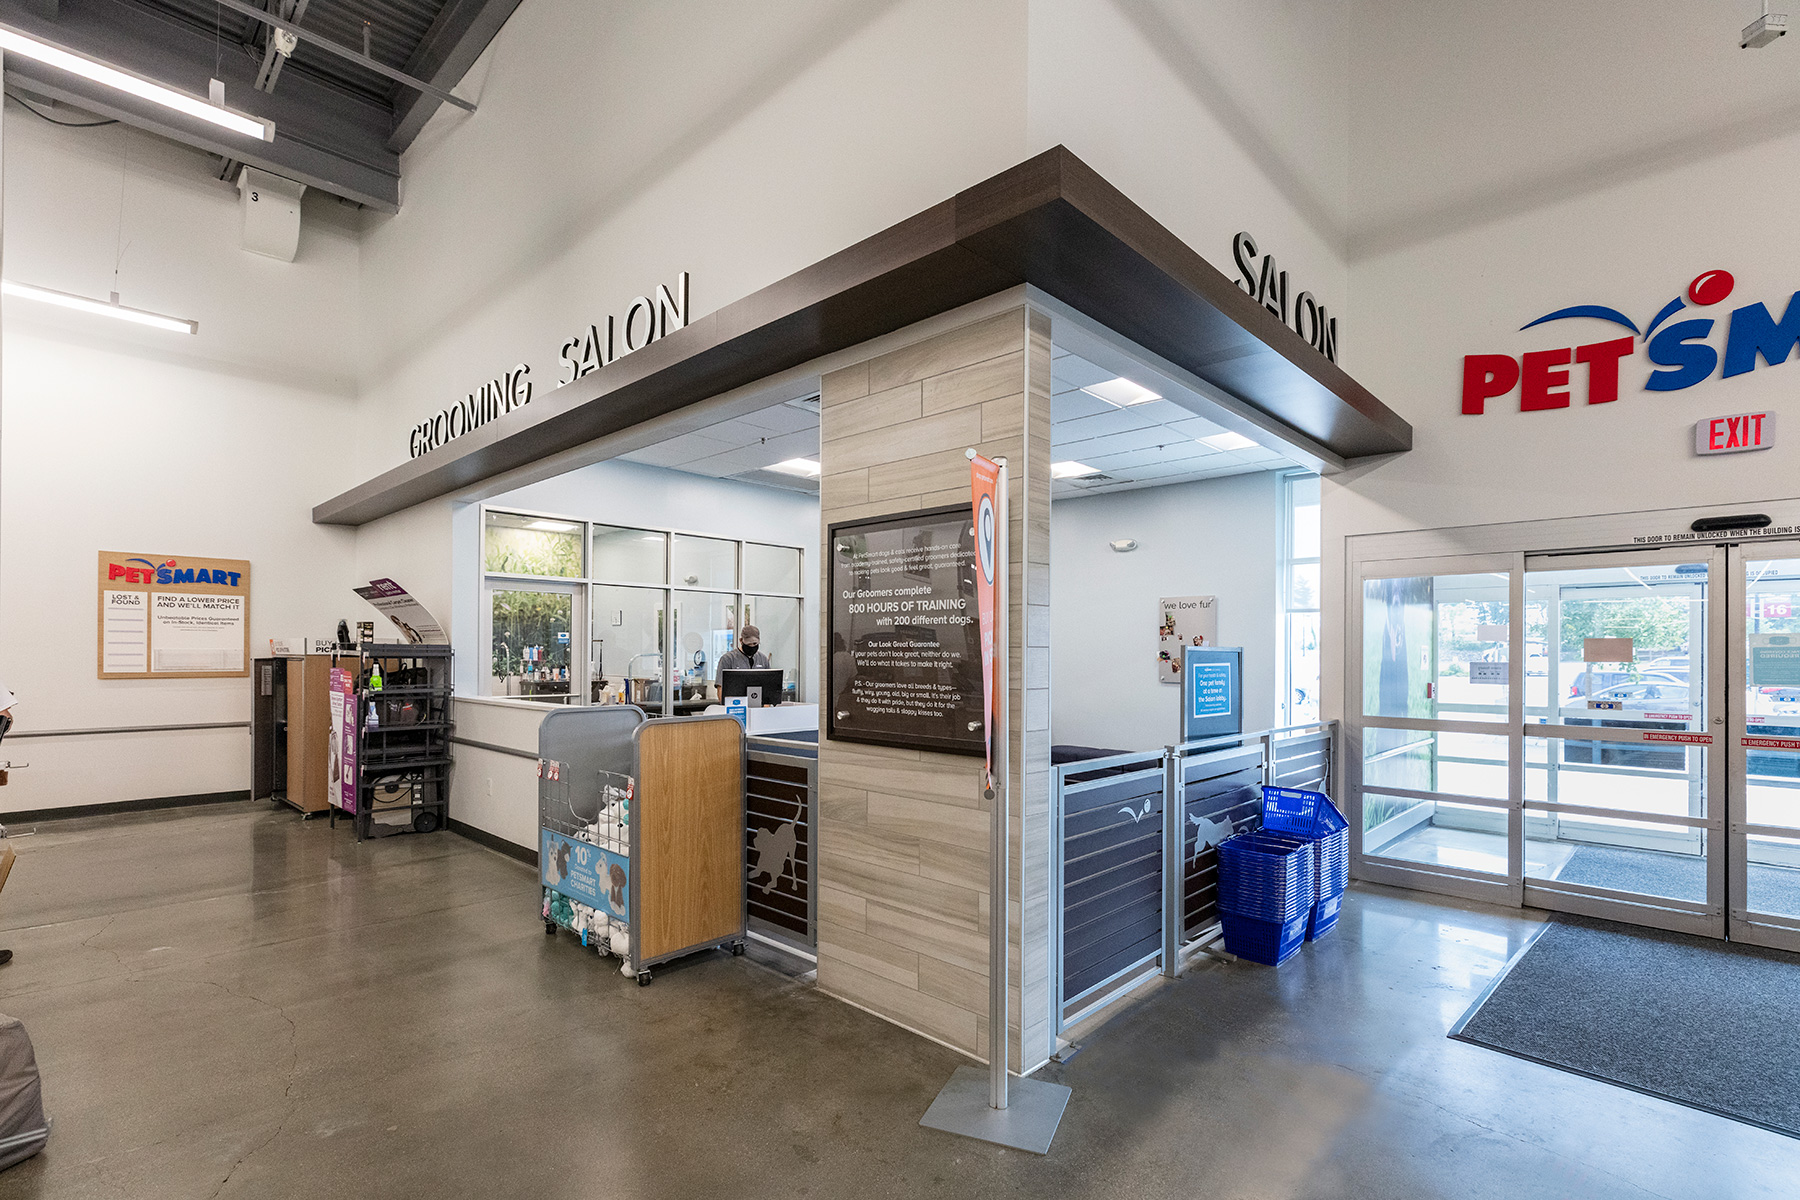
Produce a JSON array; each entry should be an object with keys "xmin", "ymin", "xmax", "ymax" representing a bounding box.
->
[{"xmin": 1525, "ymin": 804, "xmax": 1706, "ymax": 903}]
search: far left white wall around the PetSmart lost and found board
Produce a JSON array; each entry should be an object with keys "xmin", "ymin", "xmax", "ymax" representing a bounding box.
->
[{"xmin": 0, "ymin": 115, "xmax": 358, "ymax": 811}]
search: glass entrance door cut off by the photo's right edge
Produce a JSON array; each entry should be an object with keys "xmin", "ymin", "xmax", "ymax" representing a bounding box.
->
[{"xmin": 1728, "ymin": 542, "xmax": 1800, "ymax": 950}]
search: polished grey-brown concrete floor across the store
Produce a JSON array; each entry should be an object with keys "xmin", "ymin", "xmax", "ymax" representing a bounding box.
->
[{"xmin": 0, "ymin": 804, "xmax": 1800, "ymax": 1200}]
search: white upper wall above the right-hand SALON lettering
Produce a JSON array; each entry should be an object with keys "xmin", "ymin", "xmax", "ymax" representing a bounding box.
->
[{"xmin": 1026, "ymin": 0, "xmax": 1357, "ymax": 365}]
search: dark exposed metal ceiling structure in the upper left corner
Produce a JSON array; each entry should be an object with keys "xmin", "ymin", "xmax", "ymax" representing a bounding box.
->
[{"xmin": 0, "ymin": 0, "xmax": 518, "ymax": 212}]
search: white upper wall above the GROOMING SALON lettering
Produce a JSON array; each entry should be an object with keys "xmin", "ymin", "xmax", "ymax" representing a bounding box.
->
[{"xmin": 362, "ymin": 0, "xmax": 1026, "ymax": 475}]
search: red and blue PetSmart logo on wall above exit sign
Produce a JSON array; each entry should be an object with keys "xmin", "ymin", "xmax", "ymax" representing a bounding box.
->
[{"xmin": 1463, "ymin": 272, "xmax": 1800, "ymax": 416}]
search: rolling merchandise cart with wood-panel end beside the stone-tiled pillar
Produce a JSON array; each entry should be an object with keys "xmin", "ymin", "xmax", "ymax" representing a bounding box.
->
[{"xmin": 538, "ymin": 705, "xmax": 745, "ymax": 984}]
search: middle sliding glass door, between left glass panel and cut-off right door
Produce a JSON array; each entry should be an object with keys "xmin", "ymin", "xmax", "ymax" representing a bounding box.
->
[{"xmin": 1523, "ymin": 549, "xmax": 1724, "ymax": 937}]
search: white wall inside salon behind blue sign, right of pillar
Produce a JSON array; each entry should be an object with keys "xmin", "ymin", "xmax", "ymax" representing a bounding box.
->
[{"xmin": 1049, "ymin": 471, "xmax": 1282, "ymax": 750}]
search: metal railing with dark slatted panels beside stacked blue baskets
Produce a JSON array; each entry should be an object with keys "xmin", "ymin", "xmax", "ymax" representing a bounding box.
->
[{"xmin": 1051, "ymin": 721, "xmax": 1337, "ymax": 1034}]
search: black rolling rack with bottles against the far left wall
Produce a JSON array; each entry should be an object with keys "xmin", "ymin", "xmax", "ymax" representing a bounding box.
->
[{"xmin": 331, "ymin": 642, "xmax": 455, "ymax": 842}]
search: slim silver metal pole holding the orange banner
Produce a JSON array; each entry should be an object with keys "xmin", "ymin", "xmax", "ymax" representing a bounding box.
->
[{"xmin": 988, "ymin": 459, "xmax": 1012, "ymax": 1108}]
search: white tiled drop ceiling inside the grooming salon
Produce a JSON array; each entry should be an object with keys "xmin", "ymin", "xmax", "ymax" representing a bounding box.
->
[{"xmin": 623, "ymin": 345, "xmax": 1292, "ymax": 500}]
